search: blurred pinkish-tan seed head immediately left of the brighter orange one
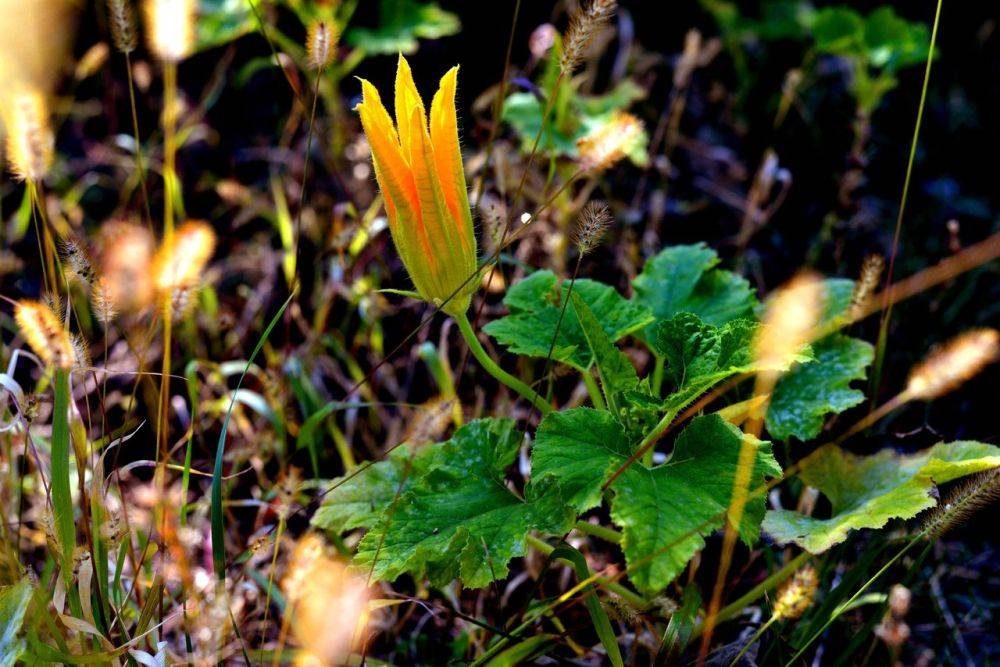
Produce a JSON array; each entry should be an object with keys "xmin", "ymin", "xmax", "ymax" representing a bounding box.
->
[{"xmin": 91, "ymin": 220, "xmax": 154, "ymax": 314}]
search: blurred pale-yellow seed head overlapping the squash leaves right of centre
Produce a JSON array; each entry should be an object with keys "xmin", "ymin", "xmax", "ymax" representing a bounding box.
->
[{"xmin": 754, "ymin": 273, "xmax": 826, "ymax": 370}]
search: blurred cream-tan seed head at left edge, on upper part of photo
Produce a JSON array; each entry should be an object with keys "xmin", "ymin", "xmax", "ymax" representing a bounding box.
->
[{"xmin": 2, "ymin": 89, "xmax": 55, "ymax": 183}]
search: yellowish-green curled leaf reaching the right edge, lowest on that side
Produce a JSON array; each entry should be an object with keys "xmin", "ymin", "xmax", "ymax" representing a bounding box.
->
[{"xmin": 763, "ymin": 441, "xmax": 1000, "ymax": 553}]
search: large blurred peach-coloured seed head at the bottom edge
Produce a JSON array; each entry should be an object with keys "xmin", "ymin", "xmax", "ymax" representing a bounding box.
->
[{"xmin": 282, "ymin": 533, "xmax": 368, "ymax": 665}]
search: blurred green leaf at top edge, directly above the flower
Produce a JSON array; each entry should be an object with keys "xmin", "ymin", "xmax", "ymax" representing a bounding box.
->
[{"xmin": 346, "ymin": 0, "xmax": 462, "ymax": 55}]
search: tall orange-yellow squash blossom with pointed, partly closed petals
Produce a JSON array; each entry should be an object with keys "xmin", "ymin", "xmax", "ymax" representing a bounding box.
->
[{"xmin": 357, "ymin": 56, "xmax": 477, "ymax": 315}]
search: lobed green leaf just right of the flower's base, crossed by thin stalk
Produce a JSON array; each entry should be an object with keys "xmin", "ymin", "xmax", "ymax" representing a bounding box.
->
[{"xmin": 483, "ymin": 270, "xmax": 653, "ymax": 371}]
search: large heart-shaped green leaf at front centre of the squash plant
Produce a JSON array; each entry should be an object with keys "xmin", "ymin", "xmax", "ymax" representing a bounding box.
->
[{"xmin": 531, "ymin": 408, "xmax": 781, "ymax": 593}]
